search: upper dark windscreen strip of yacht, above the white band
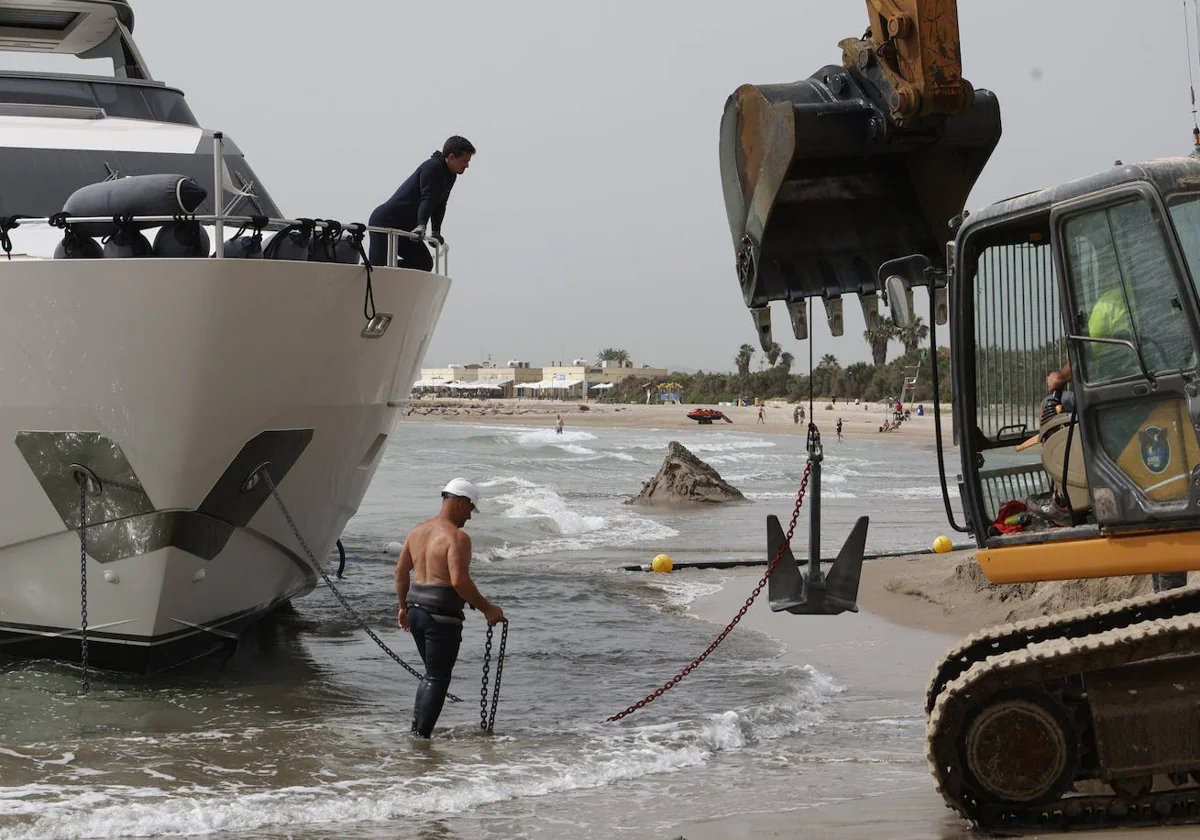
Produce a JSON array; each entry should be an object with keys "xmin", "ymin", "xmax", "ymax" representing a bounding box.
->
[{"xmin": 0, "ymin": 74, "xmax": 199, "ymax": 126}]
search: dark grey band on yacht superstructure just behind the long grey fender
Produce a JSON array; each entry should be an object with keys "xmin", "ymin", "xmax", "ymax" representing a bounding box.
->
[{"xmin": 0, "ymin": 148, "xmax": 282, "ymax": 218}]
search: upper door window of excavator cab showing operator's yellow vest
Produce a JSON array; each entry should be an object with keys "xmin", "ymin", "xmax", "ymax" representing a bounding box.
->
[{"xmin": 1063, "ymin": 199, "xmax": 1195, "ymax": 383}]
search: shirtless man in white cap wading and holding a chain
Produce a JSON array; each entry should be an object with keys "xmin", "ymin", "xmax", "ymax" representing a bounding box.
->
[{"xmin": 396, "ymin": 479, "xmax": 504, "ymax": 738}]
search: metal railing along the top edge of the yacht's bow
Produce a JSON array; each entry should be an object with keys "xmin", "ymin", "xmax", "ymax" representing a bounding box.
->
[{"xmin": 0, "ymin": 132, "xmax": 450, "ymax": 275}]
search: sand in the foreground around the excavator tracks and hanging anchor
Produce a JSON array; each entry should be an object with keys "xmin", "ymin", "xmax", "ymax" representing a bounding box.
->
[{"xmin": 678, "ymin": 552, "xmax": 1200, "ymax": 840}]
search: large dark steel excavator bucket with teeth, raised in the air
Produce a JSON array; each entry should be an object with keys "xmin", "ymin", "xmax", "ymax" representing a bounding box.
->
[{"xmin": 720, "ymin": 63, "xmax": 1001, "ymax": 347}]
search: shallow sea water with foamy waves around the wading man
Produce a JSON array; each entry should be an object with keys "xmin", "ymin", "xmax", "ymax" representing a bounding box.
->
[{"xmin": 0, "ymin": 422, "xmax": 944, "ymax": 840}]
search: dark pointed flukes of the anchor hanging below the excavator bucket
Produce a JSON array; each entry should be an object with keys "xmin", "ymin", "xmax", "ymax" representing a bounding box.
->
[{"xmin": 767, "ymin": 516, "xmax": 869, "ymax": 616}]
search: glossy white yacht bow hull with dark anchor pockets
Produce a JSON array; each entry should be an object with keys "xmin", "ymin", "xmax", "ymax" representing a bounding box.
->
[{"xmin": 0, "ymin": 259, "xmax": 450, "ymax": 671}]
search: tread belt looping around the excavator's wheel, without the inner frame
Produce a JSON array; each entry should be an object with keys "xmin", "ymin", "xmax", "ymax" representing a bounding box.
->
[{"xmin": 925, "ymin": 609, "xmax": 1200, "ymax": 832}]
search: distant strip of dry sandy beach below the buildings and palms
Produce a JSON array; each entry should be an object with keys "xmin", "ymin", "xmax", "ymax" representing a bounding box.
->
[{"xmin": 403, "ymin": 397, "xmax": 952, "ymax": 443}]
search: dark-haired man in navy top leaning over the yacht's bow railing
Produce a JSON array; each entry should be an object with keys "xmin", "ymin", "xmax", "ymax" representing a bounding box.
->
[{"xmin": 370, "ymin": 134, "xmax": 475, "ymax": 271}]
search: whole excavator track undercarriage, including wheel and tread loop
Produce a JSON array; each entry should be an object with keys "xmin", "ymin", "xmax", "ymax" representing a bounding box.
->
[{"xmin": 925, "ymin": 609, "xmax": 1200, "ymax": 833}]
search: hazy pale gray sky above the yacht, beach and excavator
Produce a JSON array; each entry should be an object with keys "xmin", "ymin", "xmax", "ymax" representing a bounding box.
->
[{"xmin": 134, "ymin": 0, "xmax": 1196, "ymax": 371}]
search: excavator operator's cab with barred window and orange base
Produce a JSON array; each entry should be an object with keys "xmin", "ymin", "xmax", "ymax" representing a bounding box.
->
[{"xmin": 950, "ymin": 158, "xmax": 1200, "ymax": 583}]
